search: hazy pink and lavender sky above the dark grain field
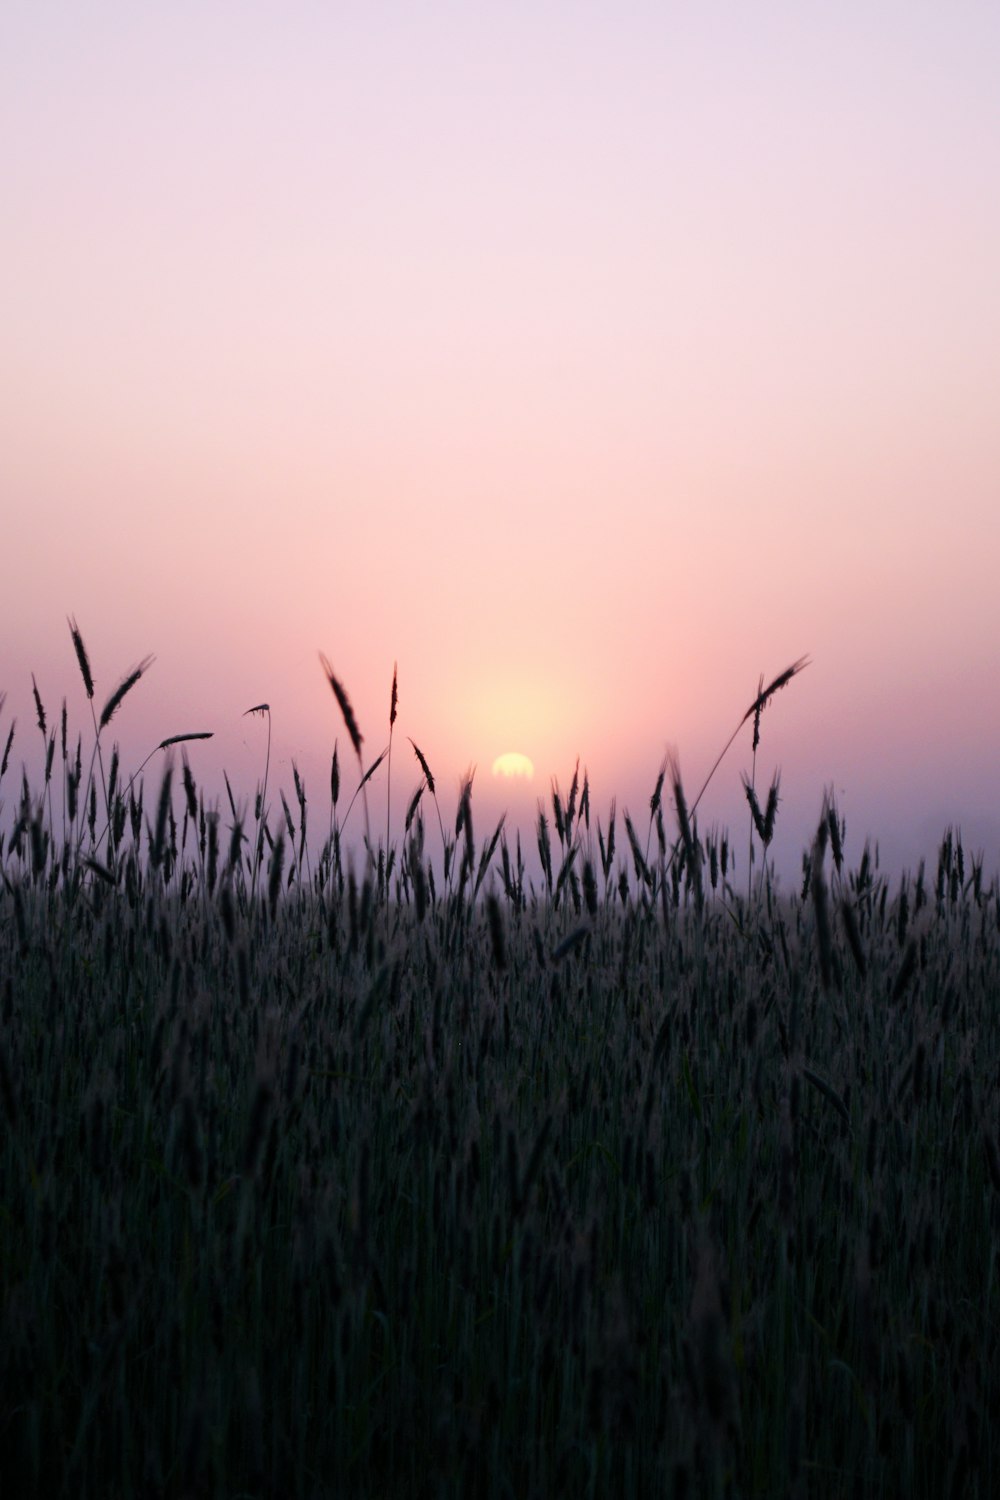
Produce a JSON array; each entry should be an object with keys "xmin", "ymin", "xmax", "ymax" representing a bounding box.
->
[{"xmin": 0, "ymin": 0, "xmax": 1000, "ymax": 872}]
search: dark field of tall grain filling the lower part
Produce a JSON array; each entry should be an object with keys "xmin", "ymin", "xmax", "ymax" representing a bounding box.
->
[{"xmin": 0, "ymin": 657, "xmax": 1000, "ymax": 1500}]
